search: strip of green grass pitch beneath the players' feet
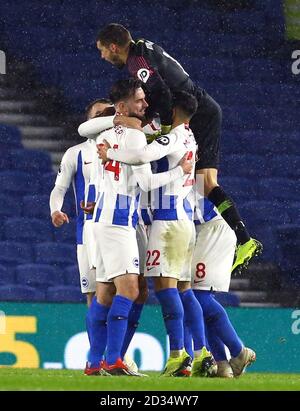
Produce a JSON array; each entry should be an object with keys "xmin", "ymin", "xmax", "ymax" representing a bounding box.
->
[{"xmin": 0, "ymin": 368, "xmax": 300, "ymax": 391}]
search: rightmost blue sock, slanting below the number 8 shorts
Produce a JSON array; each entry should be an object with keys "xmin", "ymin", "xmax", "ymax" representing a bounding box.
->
[{"xmin": 194, "ymin": 290, "xmax": 243, "ymax": 357}]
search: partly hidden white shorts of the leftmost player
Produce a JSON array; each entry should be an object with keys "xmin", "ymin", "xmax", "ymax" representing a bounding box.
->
[{"xmin": 77, "ymin": 244, "xmax": 96, "ymax": 294}]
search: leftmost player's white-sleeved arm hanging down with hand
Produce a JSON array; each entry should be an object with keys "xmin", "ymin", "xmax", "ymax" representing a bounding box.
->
[{"xmin": 49, "ymin": 150, "xmax": 76, "ymax": 227}]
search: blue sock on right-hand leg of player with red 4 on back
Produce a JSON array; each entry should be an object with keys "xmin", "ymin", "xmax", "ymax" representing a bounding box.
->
[{"xmin": 106, "ymin": 295, "xmax": 133, "ymax": 365}]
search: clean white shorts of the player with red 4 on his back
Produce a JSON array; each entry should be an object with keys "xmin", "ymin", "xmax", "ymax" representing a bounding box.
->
[{"xmin": 94, "ymin": 223, "xmax": 140, "ymax": 282}]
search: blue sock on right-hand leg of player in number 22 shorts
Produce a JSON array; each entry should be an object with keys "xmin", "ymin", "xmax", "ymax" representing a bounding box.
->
[{"xmin": 179, "ymin": 288, "xmax": 206, "ymax": 351}]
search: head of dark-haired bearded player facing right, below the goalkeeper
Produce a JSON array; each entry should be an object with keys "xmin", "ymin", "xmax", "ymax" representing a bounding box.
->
[{"xmin": 109, "ymin": 77, "xmax": 148, "ymax": 120}]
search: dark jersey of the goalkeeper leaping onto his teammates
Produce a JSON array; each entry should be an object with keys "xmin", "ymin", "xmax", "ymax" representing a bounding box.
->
[{"xmin": 126, "ymin": 40, "xmax": 202, "ymax": 125}]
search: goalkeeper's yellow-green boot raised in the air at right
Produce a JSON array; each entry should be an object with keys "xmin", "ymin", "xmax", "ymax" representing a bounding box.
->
[{"xmin": 231, "ymin": 238, "xmax": 263, "ymax": 274}]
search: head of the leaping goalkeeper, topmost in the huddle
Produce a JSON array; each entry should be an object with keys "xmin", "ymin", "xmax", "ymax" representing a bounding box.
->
[{"xmin": 96, "ymin": 23, "xmax": 132, "ymax": 68}]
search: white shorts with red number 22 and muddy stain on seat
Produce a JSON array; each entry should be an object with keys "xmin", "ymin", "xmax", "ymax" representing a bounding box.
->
[{"xmin": 145, "ymin": 220, "xmax": 195, "ymax": 281}]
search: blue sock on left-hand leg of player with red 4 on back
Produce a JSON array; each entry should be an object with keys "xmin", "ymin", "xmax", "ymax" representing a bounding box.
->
[{"xmin": 86, "ymin": 297, "xmax": 110, "ymax": 367}]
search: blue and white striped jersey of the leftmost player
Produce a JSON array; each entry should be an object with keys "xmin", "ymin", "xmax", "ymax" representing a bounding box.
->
[{"xmin": 55, "ymin": 140, "xmax": 96, "ymax": 244}]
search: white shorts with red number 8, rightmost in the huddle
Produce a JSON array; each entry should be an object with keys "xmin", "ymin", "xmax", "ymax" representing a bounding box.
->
[{"xmin": 192, "ymin": 219, "xmax": 236, "ymax": 292}]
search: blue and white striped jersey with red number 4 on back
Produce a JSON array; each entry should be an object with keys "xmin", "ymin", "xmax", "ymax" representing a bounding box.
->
[{"xmin": 94, "ymin": 126, "xmax": 183, "ymax": 228}]
